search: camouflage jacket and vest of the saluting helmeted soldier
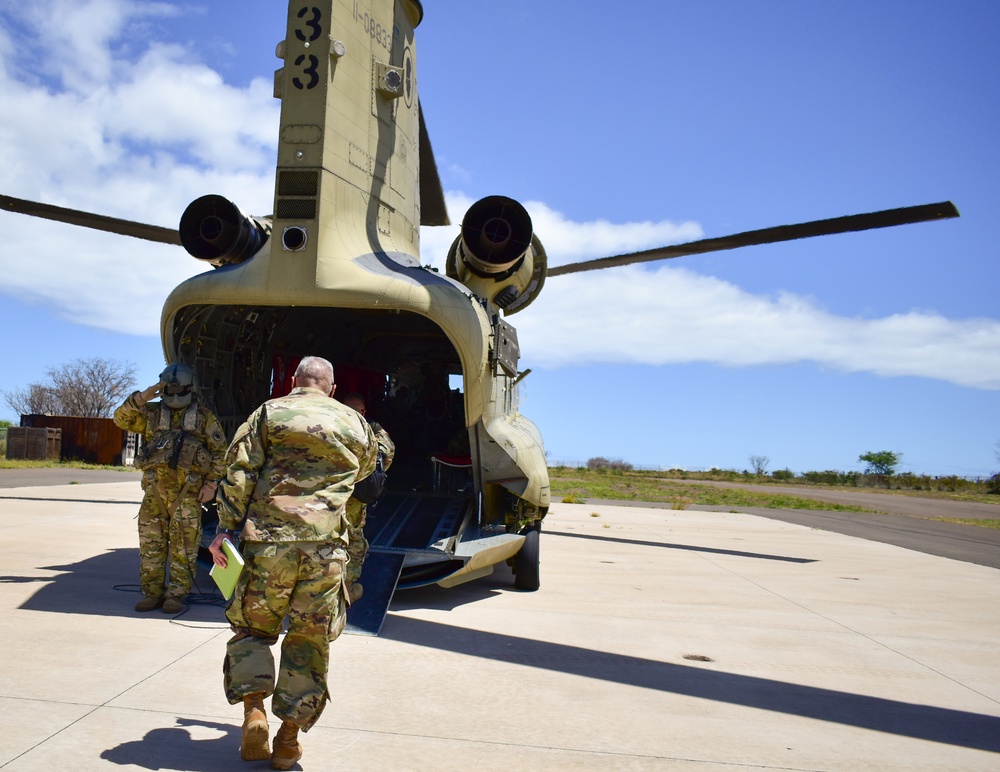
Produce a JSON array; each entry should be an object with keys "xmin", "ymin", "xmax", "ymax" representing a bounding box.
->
[{"xmin": 114, "ymin": 391, "xmax": 228, "ymax": 485}]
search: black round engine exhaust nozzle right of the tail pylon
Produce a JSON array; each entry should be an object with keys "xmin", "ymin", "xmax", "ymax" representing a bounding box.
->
[{"xmin": 460, "ymin": 196, "xmax": 532, "ymax": 277}]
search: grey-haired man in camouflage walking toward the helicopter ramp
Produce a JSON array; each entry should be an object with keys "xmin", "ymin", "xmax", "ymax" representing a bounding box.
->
[{"xmin": 209, "ymin": 357, "xmax": 378, "ymax": 769}]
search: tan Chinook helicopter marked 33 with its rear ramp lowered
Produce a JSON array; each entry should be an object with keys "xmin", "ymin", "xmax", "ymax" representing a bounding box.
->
[{"xmin": 0, "ymin": 0, "xmax": 958, "ymax": 634}]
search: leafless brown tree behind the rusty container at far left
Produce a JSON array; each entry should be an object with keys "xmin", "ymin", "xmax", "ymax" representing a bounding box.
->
[{"xmin": 4, "ymin": 357, "xmax": 136, "ymax": 418}]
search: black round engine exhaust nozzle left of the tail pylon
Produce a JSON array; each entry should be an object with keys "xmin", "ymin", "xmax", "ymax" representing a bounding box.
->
[{"xmin": 178, "ymin": 195, "xmax": 271, "ymax": 268}]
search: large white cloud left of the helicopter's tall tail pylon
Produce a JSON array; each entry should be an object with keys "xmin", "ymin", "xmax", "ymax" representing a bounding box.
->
[{"xmin": 0, "ymin": 0, "xmax": 278, "ymax": 334}]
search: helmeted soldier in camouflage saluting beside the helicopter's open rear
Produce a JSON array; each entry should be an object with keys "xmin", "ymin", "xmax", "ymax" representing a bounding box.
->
[{"xmin": 114, "ymin": 362, "xmax": 227, "ymax": 614}]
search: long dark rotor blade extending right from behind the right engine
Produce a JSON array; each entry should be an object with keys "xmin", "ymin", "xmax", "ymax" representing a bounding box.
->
[{"xmin": 546, "ymin": 201, "xmax": 959, "ymax": 276}]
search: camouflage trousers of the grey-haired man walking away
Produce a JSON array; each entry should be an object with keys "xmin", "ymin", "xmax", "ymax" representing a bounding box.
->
[{"xmin": 223, "ymin": 542, "xmax": 347, "ymax": 730}]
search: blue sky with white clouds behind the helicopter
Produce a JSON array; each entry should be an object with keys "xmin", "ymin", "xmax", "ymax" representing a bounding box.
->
[{"xmin": 0, "ymin": 0, "xmax": 1000, "ymax": 475}]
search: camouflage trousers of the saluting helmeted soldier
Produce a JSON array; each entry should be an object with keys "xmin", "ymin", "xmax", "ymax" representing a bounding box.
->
[{"xmin": 139, "ymin": 485, "xmax": 201, "ymax": 600}]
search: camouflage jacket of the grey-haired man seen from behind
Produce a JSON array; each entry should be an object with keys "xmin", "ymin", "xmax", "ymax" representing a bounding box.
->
[{"xmin": 219, "ymin": 387, "xmax": 378, "ymax": 545}]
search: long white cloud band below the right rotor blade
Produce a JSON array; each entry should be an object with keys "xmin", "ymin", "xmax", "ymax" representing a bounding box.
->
[{"xmin": 511, "ymin": 266, "xmax": 1000, "ymax": 389}]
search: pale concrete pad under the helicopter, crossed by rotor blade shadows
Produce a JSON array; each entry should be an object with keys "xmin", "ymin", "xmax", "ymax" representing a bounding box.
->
[{"xmin": 0, "ymin": 480, "xmax": 1000, "ymax": 772}]
